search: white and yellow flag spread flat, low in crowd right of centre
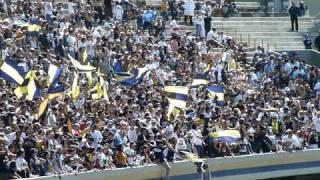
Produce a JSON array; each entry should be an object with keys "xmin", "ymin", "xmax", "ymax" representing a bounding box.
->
[{"xmin": 210, "ymin": 130, "xmax": 241, "ymax": 143}]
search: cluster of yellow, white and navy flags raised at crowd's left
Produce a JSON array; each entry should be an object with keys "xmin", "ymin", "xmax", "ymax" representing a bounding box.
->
[{"xmin": 0, "ymin": 50, "xmax": 110, "ymax": 119}]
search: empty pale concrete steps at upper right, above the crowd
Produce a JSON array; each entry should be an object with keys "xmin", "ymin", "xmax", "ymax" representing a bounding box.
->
[{"xmin": 176, "ymin": 17, "xmax": 317, "ymax": 50}]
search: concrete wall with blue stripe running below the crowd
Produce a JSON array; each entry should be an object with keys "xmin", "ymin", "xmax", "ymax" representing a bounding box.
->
[{"xmin": 26, "ymin": 150, "xmax": 320, "ymax": 180}]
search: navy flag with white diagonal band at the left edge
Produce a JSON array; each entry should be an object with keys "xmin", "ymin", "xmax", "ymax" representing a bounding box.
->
[{"xmin": 0, "ymin": 59, "xmax": 26, "ymax": 85}]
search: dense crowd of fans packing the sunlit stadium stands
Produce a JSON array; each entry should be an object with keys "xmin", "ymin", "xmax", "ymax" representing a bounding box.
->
[{"xmin": 0, "ymin": 0, "xmax": 320, "ymax": 179}]
